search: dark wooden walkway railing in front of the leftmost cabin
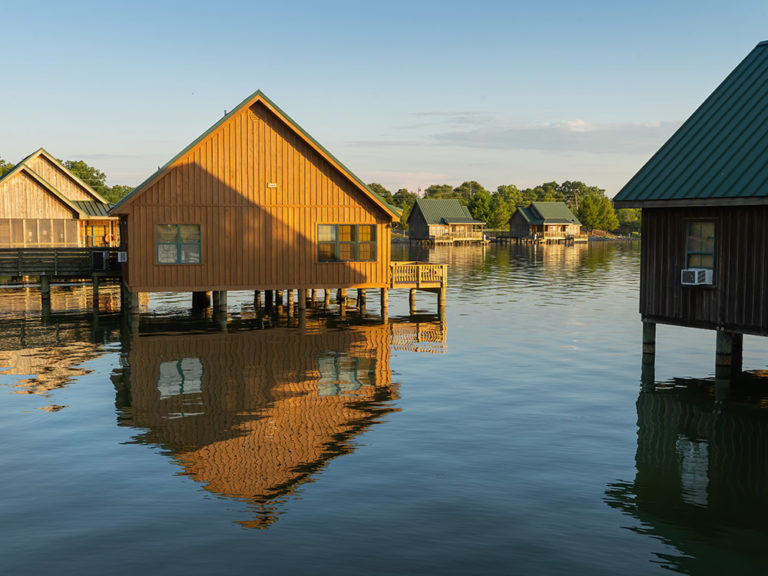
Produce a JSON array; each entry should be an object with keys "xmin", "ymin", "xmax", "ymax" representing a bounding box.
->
[{"xmin": 0, "ymin": 248, "xmax": 120, "ymax": 277}]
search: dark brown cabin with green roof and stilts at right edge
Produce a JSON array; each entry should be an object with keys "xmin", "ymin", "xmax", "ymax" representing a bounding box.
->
[{"xmin": 614, "ymin": 42, "xmax": 768, "ymax": 377}]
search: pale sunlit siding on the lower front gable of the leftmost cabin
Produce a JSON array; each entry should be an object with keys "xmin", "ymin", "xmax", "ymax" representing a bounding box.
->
[{"xmin": 0, "ymin": 170, "xmax": 76, "ymax": 219}]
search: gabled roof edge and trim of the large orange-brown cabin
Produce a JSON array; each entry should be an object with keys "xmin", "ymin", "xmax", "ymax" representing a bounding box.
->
[{"xmin": 112, "ymin": 90, "xmax": 402, "ymax": 218}]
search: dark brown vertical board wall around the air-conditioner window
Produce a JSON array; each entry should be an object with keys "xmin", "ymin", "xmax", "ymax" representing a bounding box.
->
[{"xmin": 640, "ymin": 206, "xmax": 768, "ymax": 335}]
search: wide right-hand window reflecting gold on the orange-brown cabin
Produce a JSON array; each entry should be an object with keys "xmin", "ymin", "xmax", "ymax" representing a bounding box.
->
[{"xmin": 317, "ymin": 224, "xmax": 376, "ymax": 262}]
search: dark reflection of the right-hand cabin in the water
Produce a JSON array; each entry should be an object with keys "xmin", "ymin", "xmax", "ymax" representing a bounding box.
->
[{"xmin": 605, "ymin": 376, "xmax": 768, "ymax": 574}]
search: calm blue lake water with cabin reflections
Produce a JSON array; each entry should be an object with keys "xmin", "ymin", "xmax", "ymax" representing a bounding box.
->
[{"xmin": 0, "ymin": 243, "xmax": 768, "ymax": 576}]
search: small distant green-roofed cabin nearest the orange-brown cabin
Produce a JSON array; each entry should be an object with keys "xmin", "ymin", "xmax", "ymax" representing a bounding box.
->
[{"xmin": 408, "ymin": 198, "xmax": 485, "ymax": 244}]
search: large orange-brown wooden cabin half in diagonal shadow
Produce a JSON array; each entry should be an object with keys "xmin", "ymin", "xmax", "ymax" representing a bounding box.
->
[{"xmin": 111, "ymin": 91, "xmax": 399, "ymax": 292}]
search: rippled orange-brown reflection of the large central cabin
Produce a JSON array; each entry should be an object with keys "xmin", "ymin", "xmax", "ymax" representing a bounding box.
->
[{"xmin": 118, "ymin": 320, "xmax": 398, "ymax": 528}]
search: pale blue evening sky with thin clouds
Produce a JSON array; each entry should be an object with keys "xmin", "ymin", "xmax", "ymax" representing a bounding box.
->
[{"xmin": 0, "ymin": 0, "xmax": 768, "ymax": 196}]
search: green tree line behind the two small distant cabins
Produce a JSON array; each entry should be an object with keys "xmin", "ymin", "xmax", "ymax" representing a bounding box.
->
[{"xmin": 368, "ymin": 180, "xmax": 640, "ymax": 234}]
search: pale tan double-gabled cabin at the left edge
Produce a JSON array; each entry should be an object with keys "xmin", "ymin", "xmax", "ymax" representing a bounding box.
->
[{"xmin": 0, "ymin": 148, "xmax": 120, "ymax": 248}]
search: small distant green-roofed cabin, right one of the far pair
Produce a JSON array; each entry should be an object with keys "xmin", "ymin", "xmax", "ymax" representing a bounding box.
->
[{"xmin": 509, "ymin": 202, "xmax": 587, "ymax": 242}]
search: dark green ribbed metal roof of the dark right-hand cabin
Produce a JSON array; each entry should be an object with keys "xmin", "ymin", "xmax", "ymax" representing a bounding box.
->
[{"xmin": 614, "ymin": 41, "xmax": 768, "ymax": 207}]
